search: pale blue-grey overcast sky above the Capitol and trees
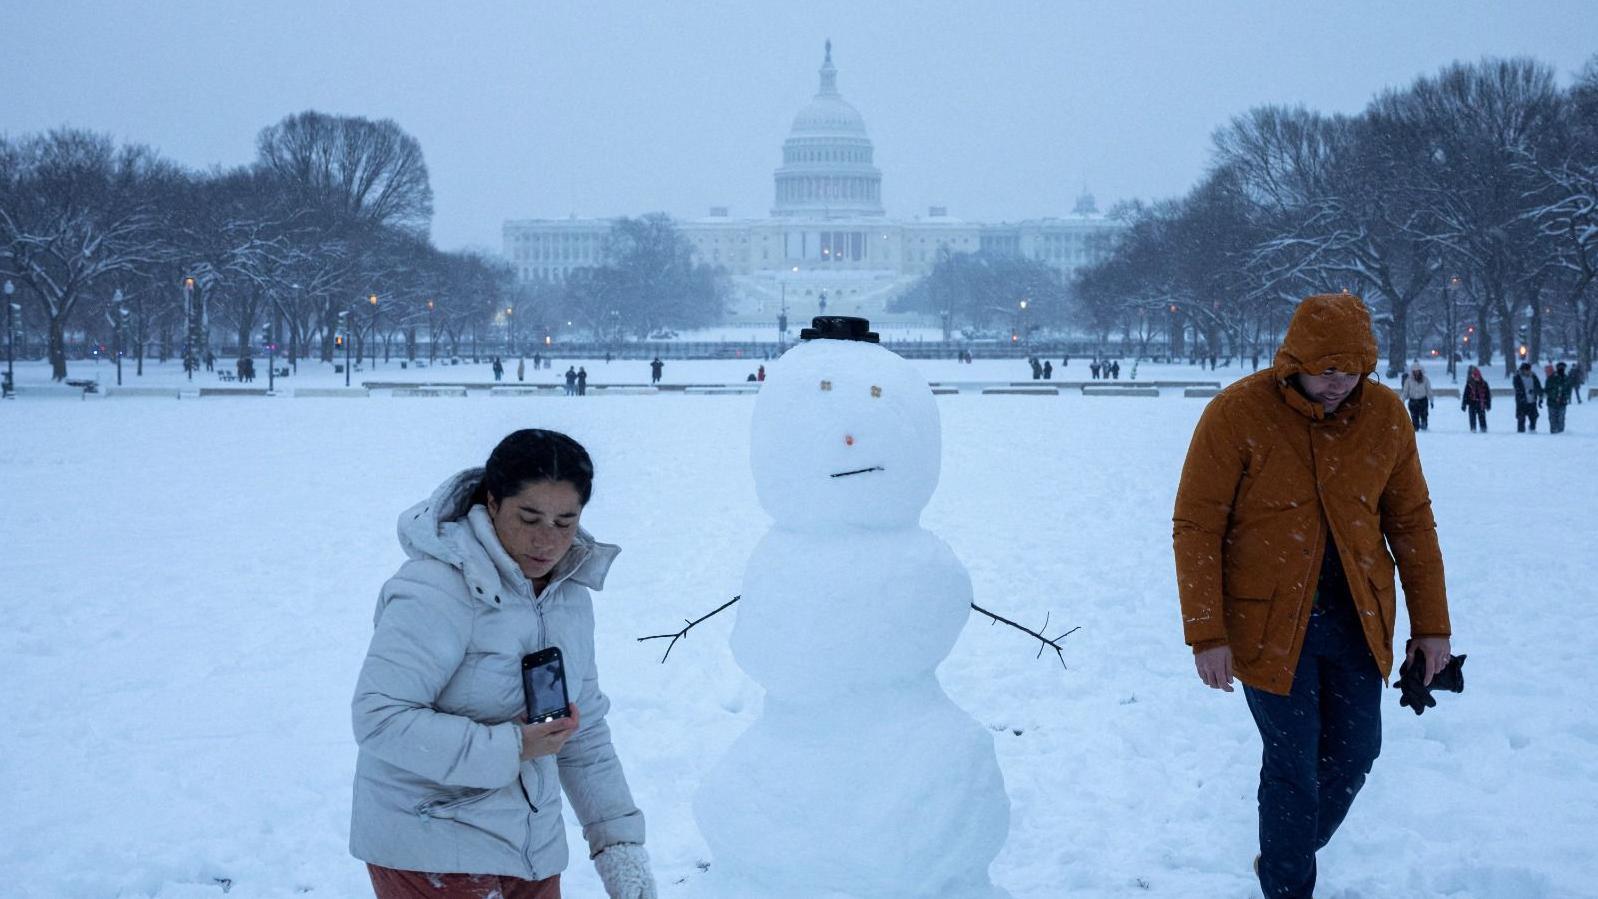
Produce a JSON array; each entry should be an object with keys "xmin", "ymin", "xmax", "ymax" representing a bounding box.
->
[{"xmin": 0, "ymin": 0, "xmax": 1598, "ymax": 251}]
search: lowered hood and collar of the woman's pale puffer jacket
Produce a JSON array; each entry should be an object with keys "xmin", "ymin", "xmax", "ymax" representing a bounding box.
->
[{"xmin": 398, "ymin": 468, "xmax": 622, "ymax": 597}]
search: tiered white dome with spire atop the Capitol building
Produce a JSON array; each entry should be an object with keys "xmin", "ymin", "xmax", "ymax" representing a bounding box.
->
[{"xmin": 772, "ymin": 40, "xmax": 884, "ymax": 219}]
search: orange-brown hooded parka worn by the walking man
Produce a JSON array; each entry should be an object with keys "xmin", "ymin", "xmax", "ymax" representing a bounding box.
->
[{"xmin": 1173, "ymin": 294, "xmax": 1449, "ymax": 695}]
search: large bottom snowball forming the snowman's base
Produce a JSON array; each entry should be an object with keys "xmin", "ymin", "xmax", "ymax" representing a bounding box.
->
[{"xmin": 694, "ymin": 677, "xmax": 1010, "ymax": 899}]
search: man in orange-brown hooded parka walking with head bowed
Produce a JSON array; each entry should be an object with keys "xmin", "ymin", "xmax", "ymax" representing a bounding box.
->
[{"xmin": 1173, "ymin": 294, "xmax": 1451, "ymax": 899}]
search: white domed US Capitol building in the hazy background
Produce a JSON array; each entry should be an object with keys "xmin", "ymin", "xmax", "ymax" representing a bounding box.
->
[{"xmin": 503, "ymin": 42, "xmax": 1122, "ymax": 326}]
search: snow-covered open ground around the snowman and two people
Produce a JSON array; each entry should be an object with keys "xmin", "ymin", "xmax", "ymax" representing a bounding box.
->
[{"xmin": 0, "ymin": 361, "xmax": 1598, "ymax": 899}]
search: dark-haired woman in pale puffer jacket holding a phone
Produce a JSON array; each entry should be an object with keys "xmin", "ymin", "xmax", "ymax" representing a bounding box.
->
[{"xmin": 350, "ymin": 430, "xmax": 655, "ymax": 899}]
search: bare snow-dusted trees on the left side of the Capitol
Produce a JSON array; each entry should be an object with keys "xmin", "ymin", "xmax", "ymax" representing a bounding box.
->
[{"xmin": 0, "ymin": 112, "xmax": 725, "ymax": 380}]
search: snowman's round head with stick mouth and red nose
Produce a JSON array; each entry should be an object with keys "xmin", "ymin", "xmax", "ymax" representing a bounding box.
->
[{"xmin": 749, "ymin": 333, "xmax": 943, "ymax": 530}]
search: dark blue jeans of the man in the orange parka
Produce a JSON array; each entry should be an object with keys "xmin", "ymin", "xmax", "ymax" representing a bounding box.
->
[{"xmin": 1243, "ymin": 602, "xmax": 1382, "ymax": 899}]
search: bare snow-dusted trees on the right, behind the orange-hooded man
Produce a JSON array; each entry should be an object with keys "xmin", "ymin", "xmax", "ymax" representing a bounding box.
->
[{"xmin": 1074, "ymin": 57, "xmax": 1598, "ymax": 370}]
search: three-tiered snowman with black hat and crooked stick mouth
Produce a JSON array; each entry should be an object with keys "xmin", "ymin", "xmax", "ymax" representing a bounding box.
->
[{"xmin": 694, "ymin": 316, "xmax": 1010, "ymax": 899}]
